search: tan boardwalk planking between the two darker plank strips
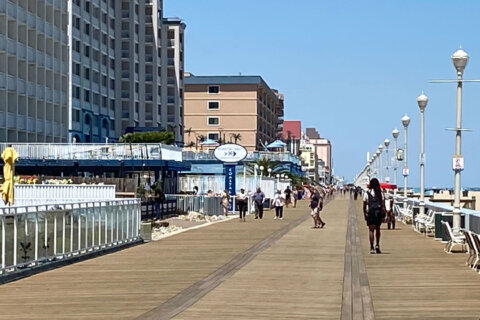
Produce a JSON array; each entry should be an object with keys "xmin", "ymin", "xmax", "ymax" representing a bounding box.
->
[{"xmin": 175, "ymin": 201, "xmax": 348, "ymax": 319}]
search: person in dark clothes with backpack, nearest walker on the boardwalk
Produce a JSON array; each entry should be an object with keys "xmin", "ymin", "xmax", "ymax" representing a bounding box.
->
[{"xmin": 363, "ymin": 178, "xmax": 386, "ymax": 254}]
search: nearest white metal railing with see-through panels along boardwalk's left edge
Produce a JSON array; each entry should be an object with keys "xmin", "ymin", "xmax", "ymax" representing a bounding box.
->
[{"xmin": 0, "ymin": 199, "xmax": 140, "ymax": 274}]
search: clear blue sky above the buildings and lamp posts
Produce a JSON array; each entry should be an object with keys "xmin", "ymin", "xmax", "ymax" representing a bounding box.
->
[{"xmin": 164, "ymin": 0, "xmax": 480, "ymax": 187}]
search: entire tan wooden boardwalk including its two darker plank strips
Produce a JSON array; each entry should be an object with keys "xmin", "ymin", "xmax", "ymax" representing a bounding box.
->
[{"xmin": 0, "ymin": 198, "xmax": 480, "ymax": 319}]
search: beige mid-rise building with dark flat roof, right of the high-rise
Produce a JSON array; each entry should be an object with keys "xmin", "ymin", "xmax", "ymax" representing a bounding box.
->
[{"xmin": 184, "ymin": 74, "xmax": 283, "ymax": 151}]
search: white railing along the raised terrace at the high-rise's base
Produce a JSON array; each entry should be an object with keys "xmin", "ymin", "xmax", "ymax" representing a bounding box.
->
[{"xmin": 0, "ymin": 143, "xmax": 182, "ymax": 161}]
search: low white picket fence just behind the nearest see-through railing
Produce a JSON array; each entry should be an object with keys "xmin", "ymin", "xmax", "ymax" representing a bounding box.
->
[{"xmin": 4, "ymin": 184, "xmax": 116, "ymax": 207}]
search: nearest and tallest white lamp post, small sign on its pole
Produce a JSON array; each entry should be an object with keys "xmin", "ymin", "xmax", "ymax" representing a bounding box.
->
[{"xmin": 452, "ymin": 48, "xmax": 468, "ymax": 229}]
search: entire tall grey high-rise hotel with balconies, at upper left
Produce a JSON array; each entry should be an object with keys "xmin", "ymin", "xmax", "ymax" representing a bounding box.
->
[{"xmin": 0, "ymin": 0, "xmax": 185, "ymax": 142}]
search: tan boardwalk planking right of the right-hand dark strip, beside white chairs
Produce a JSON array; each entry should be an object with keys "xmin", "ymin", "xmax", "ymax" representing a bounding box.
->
[{"xmin": 356, "ymin": 201, "xmax": 480, "ymax": 320}]
